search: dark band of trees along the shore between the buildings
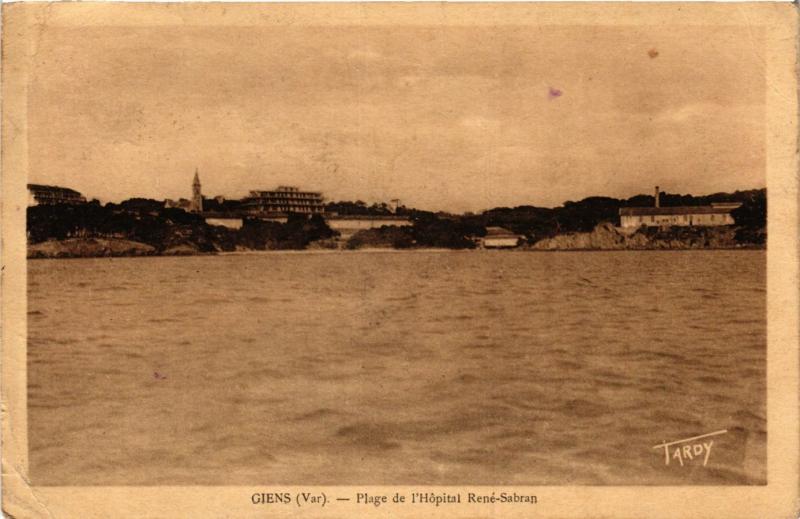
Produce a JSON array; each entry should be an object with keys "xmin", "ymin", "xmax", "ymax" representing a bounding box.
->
[{"xmin": 27, "ymin": 189, "xmax": 767, "ymax": 252}]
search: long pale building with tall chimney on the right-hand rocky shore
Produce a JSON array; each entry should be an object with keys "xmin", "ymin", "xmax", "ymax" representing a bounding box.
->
[{"xmin": 619, "ymin": 186, "xmax": 742, "ymax": 229}]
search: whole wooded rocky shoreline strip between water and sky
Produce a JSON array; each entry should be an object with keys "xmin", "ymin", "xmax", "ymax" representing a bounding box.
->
[{"xmin": 26, "ymin": 189, "xmax": 767, "ymax": 258}]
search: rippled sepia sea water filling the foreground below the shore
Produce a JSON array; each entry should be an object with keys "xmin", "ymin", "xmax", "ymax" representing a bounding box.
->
[{"xmin": 28, "ymin": 251, "xmax": 766, "ymax": 485}]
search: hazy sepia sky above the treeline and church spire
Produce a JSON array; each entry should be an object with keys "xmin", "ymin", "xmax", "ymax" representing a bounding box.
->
[{"xmin": 28, "ymin": 19, "xmax": 765, "ymax": 211}]
